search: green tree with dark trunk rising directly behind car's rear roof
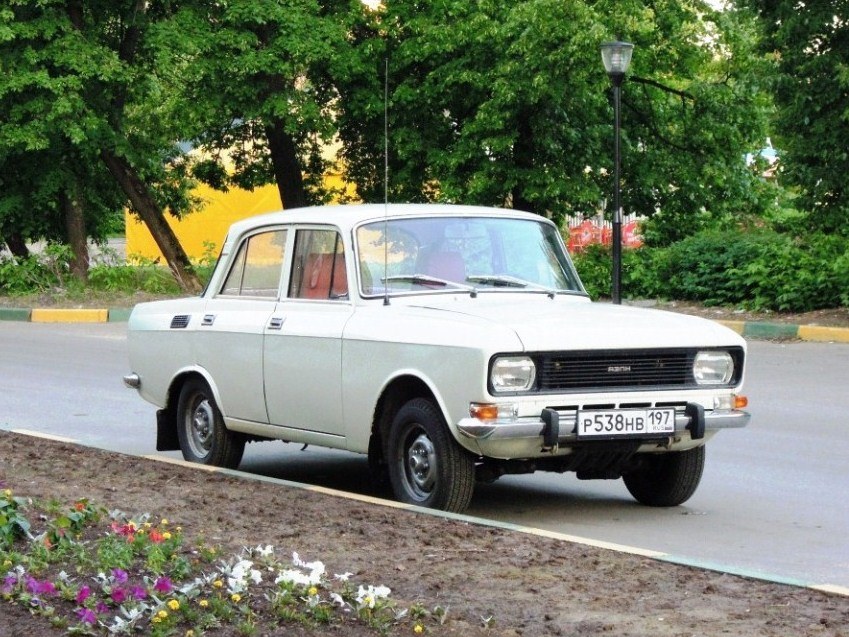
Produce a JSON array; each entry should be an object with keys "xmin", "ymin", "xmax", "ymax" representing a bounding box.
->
[{"xmin": 170, "ymin": 0, "xmax": 362, "ymax": 208}]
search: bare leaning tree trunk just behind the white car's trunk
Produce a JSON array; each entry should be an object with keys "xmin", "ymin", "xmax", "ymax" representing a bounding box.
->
[{"xmin": 100, "ymin": 150, "xmax": 203, "ymax": 294}]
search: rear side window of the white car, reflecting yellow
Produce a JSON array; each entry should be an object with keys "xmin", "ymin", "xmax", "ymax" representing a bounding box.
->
[{"xmin": 221, "ymin": 230, "xmax": 286, "ymax": 299}]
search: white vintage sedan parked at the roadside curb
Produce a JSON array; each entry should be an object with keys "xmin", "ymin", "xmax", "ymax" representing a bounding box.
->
[{"xmin": 124, "ymin": 204, "xmax": 749, "ymax": 511}]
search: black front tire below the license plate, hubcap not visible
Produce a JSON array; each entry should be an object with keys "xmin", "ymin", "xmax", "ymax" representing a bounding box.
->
[{"xmin": 623, "ymin": 445, "xmax": 705, "ymax": 507}]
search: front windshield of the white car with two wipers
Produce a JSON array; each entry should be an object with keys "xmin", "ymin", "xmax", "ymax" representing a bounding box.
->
[{"xmin": 357, "ymin": 217, "xmax": 584, "ymax": 296}]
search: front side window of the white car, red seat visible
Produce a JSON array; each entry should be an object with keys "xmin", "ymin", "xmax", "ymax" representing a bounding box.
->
[{"xmin": 289, "ymin": 229, "xmax": 348, "ymax": 299}]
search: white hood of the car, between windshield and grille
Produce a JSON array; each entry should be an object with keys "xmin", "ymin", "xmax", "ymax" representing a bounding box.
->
[{"xmin": 410, "ymin": 294, "xmax": 744, "ymax": 351}]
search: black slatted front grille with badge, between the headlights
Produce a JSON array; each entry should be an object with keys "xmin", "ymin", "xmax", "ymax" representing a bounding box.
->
[{"xmin": 534, "ymin": 348, "xmax": 743, "ymax": 392}]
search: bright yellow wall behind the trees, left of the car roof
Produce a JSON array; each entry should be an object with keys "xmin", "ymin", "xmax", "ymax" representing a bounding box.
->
[{"xmin": 124, "ymin": 175, "xmax": 353, "ymax": 264}]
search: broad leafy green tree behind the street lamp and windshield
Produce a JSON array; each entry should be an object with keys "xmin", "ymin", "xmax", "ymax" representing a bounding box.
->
[{"xmin": 340, "ymin": 0, "xmax": 769, "ymax": 241}]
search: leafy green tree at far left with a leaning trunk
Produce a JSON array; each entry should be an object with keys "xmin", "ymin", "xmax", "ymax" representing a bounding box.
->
[{"xmin": 0, "ymin": 0, "xmax": 201, "ymax": 291}]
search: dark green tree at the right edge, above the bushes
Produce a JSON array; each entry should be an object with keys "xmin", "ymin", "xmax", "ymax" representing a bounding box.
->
[{"xmin": 741, "ymin": 0, "xmax": 849, "ymax": 233}]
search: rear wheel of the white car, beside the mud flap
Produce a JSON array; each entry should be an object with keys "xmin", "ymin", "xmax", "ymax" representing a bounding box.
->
[{"xmin": 177, "ymin": 378, "xmax": 245, "ymax": 469}]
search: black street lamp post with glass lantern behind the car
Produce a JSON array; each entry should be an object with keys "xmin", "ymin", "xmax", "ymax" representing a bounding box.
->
[{"xmin": 601, "ymin": 42, "xmax": 634, "ymax": 304}]
